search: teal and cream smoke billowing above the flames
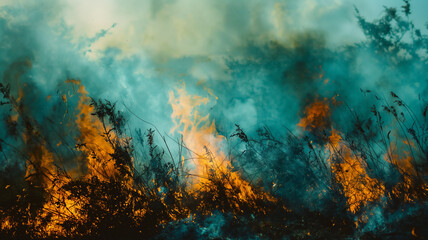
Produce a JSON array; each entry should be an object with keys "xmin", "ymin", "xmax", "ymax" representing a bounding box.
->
[{"xmin": 1, "ymin": 1, "xmax": 426, "ymax": 139}]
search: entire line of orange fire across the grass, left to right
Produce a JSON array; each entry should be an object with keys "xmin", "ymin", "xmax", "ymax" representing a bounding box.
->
[{"xmin": 0, "ymin": 80, "xmax": 422, "ymax": 238}]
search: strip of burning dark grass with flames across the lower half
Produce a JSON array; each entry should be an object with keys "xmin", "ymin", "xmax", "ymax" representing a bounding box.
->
[{"xmin": 0, "ymin": 81, "xmax": 428, "ymax": 239}]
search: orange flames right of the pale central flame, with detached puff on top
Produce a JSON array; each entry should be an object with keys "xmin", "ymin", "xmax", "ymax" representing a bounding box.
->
[{"xmin": 298, "ymin": 98, "xmax": 428, "ymax": 214}]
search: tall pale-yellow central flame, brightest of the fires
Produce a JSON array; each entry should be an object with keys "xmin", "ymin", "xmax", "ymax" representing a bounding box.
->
[{"xmin": 169, "ymin": 86, "xmax": 274, "ymax": 207}]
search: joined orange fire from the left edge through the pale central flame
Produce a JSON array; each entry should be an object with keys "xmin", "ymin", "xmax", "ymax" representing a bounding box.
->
[{"xmin": 0, "ymin": 80, "xmax": 276, "ymax": 238}]
